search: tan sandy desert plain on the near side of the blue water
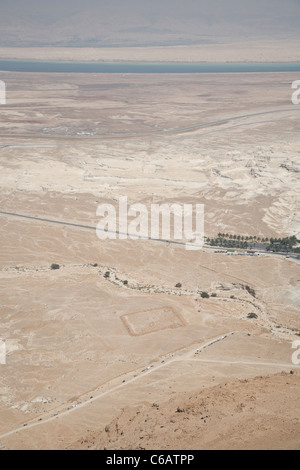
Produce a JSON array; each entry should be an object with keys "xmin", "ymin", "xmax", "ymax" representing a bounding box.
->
[{"xmin": 0, "ymin": 67, "xmax": 300, "ymax": 450}]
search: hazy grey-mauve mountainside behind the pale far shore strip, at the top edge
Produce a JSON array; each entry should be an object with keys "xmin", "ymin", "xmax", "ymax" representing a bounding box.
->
[{"xmin": 0, "ymin": 0, "xmax": 300, "ymax": 47}]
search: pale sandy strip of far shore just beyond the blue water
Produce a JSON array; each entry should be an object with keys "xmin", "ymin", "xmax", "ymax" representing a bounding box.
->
[{"xmin": 0, "ymin": 37, "xmax": 299, "ymax": 63}]
